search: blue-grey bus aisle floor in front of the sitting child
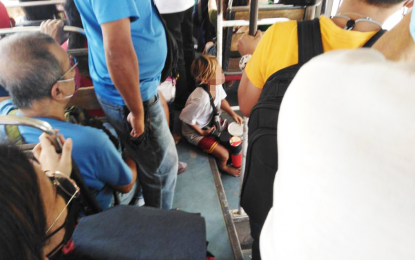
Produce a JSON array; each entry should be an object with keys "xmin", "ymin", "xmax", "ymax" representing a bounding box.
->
[{"xmin": 173, "ymin": 84, "xmax": 251, "ymax": 260}]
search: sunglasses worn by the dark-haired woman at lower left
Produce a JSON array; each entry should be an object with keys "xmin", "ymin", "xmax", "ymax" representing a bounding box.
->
[{"xmin": 45, "ymin": 171, "xmax": 80, "ymax": 235}]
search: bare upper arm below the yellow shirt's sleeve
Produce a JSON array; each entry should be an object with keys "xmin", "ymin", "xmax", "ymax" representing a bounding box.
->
[{"xmin": 238, "ymin": 71, "xmax": 262, "ymax": 117}]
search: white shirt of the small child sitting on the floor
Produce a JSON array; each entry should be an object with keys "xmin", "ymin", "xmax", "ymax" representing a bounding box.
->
[{"xmin": 179, "ymin": 85, "xmax": 226, "ymax": 127}]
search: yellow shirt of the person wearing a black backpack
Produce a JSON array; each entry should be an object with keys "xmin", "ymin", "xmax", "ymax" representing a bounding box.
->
[{"xmin": 245, "ymin": 16, "xmax": 376, "ymax": 89}]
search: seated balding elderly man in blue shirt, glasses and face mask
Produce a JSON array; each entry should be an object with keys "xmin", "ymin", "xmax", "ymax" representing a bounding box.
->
[{"xmin": 0, "ymin": 33, "xmax": 136, "ymax": 209}]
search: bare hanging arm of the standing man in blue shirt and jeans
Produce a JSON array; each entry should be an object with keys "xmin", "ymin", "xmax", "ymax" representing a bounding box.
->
[{"xmin": 101, "ymin": 18, "xmax": 144, "ymax": 137}]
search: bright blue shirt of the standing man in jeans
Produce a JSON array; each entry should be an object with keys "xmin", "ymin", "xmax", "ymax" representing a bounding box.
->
[{"xmin": 75, "ymin": 0, "xmax": 167, "ymax": 105}]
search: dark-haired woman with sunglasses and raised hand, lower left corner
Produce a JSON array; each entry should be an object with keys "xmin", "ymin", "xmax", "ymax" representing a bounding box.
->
[{"xmin": 0, "ymin": 134, "xmax": 79, "ymax": 260}]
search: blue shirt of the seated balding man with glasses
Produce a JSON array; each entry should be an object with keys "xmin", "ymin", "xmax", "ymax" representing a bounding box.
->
[{"xmin": 0, "ymin": 99, "xmax": 132, "ymax": 209}]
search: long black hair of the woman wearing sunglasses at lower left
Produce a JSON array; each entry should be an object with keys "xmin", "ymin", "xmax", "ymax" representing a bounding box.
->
[{"xmin": 0, "ymin": 144, "xmax": 46, "ymax": 260}]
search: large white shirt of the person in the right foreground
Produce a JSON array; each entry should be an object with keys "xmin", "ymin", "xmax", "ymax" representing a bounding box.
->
[{"xmin": 260, "ymin": 49, "xmax": 415, "ymax": 260}]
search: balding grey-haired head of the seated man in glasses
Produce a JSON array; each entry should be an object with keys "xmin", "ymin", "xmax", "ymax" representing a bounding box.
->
[{"xmin": 0, "ymin": 33, "xmax": 76, "ymax": 109}]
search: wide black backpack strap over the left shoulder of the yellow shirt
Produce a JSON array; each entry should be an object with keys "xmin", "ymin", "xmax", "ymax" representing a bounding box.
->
[{"xmin": 297, "ymin": 18, "xmax": 323, "ymax": 64}]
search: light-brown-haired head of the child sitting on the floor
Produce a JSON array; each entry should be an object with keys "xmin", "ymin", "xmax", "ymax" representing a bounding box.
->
[{"xmin": 191, "ymin": 55, "xmax": 225, "ymax": 85}]
